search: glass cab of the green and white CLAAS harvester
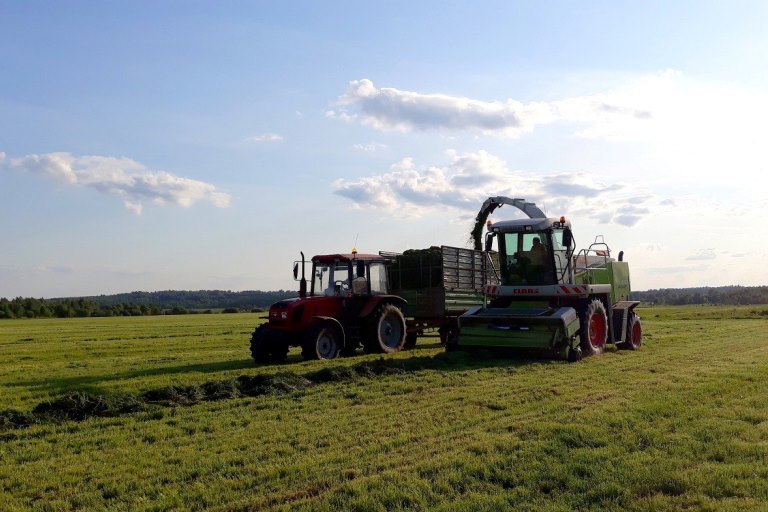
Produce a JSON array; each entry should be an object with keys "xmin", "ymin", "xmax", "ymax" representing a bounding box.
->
[{"xmin": 486, "ymin": 217, "xmax": 573, "ymax": 286}]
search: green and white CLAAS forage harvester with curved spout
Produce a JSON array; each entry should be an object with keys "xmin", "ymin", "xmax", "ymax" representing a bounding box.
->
[{"xmin": 456, "ymin": 197, "xmax": 642, "ymax": 360}]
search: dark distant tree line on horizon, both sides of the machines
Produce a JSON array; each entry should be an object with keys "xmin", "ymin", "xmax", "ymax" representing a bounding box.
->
[{"xmin": 0, "ymin": 286, "xmax": 768, "ymax": 319}]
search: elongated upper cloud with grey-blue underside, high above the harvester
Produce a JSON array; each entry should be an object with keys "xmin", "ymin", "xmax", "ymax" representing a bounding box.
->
[{"xmin": 326, "ymin": 78, "xmax": 653, "ymax": 138}]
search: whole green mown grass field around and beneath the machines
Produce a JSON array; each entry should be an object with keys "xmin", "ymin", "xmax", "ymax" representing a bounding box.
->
[{"xmin": 0, "ymin": 307, "xmax": 768, "ymax": 511}]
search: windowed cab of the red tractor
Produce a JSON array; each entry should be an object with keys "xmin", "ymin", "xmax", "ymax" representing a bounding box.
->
[{"xmin": 304, "ymin": 251, "xmax": 389, "ymax": 297}]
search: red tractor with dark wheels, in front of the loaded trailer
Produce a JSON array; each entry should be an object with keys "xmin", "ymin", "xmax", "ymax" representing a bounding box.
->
[{"xmin": 251, "ymin": 249, "xmax": 405, "ymax": 363}]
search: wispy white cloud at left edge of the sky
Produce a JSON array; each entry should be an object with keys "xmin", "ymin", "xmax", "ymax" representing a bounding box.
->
[{"xmin": 0, "ymin": 153, "xmax": 231, "ymax": 214}]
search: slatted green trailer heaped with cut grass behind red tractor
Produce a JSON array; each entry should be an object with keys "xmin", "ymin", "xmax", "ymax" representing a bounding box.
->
[{"xmin": 380, "ymin": 245, "xmax": 499, "ymax": 346}]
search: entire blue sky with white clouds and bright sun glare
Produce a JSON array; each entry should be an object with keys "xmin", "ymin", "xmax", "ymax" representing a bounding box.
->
[{"xmin": 0, "ymin": 0, "xmax": 768, "ymax": 297}]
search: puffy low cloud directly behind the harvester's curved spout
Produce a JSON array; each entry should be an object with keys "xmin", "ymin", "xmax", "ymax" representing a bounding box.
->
[{"xmin": 333, "ymin": 151, "xmax": 657, "ymax": 226}]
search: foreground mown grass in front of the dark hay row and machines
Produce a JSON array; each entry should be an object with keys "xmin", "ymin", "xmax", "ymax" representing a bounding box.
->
[{"xmin": 0, "ymin": 309, "xmax": 768, "ymax": 510}]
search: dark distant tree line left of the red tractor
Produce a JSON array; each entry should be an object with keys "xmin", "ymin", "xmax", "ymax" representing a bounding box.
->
[{"xmin": 0, "ymin": 290, "xmax": 298, "ymax": 319}]
